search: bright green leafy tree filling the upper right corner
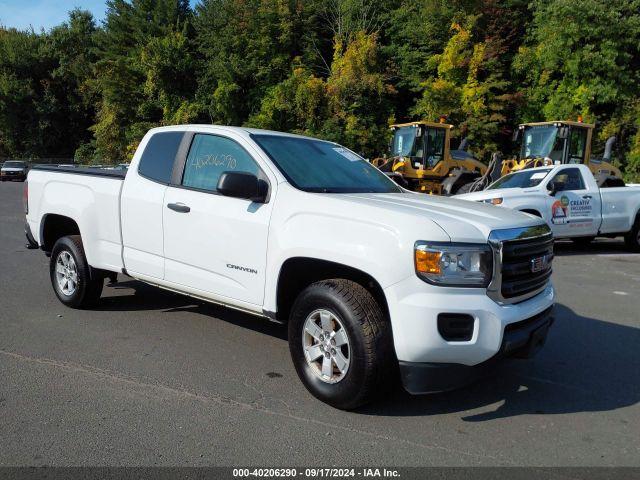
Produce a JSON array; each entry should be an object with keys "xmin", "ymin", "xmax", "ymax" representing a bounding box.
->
[{"xmin": 514, "ymin": 0, "xmax": 640, "ymax": 176}]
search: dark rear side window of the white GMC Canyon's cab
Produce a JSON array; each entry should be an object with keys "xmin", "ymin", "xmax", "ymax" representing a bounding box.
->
[{"xmin": 138, "ymin": 132, "xmax": 184, "ymax": 184}]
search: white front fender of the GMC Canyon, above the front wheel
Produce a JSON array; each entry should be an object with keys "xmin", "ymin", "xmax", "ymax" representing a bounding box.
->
[{"xmin": 264, "ymin": 187, "xmax": 450, "ymax": 311}]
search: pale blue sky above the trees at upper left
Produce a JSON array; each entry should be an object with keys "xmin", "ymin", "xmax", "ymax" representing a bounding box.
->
[{"xmin": 0, "ymin": 0, "xmax": 196, "ymax": 32}]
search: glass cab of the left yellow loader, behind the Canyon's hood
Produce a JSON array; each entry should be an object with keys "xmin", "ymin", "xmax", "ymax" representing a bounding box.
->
[{"xmin": 391, "ymin": 122, "xmax": 452, "ymax": 171}]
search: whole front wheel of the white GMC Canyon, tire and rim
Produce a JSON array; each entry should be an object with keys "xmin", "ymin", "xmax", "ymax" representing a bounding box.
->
[{"xmin": 289, "ymin": 279, "xmax": 394, "ymax": 410}]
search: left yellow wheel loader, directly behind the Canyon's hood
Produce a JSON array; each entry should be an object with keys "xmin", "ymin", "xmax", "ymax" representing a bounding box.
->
[{"xmin": 371, "ymin": 119, "xmax": 487, "ymax": 195}]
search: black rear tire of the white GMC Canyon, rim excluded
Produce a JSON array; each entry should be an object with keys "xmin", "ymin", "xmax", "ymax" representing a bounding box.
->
[{"xmin": 49, "ymin": 235, "xmax": 104, "ymax": 308}]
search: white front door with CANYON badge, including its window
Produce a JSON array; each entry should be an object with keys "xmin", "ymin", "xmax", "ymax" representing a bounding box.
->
[{"xmin": 163, "ymin": 133, "xmax": 273, "ymax": 306}]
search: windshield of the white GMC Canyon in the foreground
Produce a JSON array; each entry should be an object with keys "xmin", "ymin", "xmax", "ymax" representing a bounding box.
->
[{"xmin": 251, "ymin": 134, "xmax": 402, "ymax": 193}]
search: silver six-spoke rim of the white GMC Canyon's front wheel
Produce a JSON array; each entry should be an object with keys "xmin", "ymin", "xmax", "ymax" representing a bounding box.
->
[{"xmin": 302, "ymin": 309, "xmax": 351, "ymax": 383}]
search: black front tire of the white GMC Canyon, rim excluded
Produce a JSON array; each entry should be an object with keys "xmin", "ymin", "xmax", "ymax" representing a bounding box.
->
[{"xmin": 289, "ymin": 279, "xmax": 395, "ymax": 410}]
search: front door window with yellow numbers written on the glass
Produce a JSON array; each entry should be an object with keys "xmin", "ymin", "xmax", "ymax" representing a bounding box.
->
[{"xmin": 182, "ymin": 134, "xmax": 259, "ymax": 192}]
